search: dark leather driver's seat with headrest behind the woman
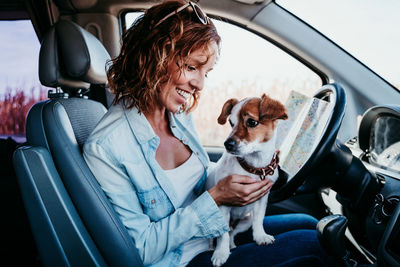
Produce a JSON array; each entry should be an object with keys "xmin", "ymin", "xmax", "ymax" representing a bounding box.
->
[{"xmin": 14, "ymin": 21, "xmax": 143, "ymax": 266}]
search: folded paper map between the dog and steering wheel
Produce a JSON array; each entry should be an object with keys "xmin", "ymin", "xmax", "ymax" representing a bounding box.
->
[{"xmin": 277, "ymin": 91, "xmax": 333, "ymax": 177}]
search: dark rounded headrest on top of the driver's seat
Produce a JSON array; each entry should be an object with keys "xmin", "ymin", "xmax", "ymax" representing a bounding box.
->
[{"xmin": 39, "ymin": 20, "xmax": 110, "ymax": 90}]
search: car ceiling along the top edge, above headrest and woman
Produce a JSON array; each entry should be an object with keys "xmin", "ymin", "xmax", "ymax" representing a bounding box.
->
[{"xmin": 0, "ymin": 0, "xmax": 271, "ymax": 32}]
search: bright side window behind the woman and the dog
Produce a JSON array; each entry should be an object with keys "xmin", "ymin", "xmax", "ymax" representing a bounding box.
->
[{"xmin": 125, "ymin": 12, "xmax": 322, "ymax": 147}]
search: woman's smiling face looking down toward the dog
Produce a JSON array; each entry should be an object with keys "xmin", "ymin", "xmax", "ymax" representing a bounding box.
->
[{"xmin": 159, "ymin": 42, "xmax": 218, "ymax": 113}]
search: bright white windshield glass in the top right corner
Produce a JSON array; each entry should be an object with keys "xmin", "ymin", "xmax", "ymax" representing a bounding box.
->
[{"xmin": 276, "ymin": 0, "xmax": 400, "ymax": 90}]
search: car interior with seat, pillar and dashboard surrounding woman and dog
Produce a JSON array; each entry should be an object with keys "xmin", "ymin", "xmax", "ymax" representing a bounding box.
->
[{"xmin": 0, "ymin": 0, "xmax": 400, "ymax": 266}]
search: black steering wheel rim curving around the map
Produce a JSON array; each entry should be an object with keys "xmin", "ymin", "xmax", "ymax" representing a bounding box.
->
[{"xmin": 269, "ymin": 83, "xmax": 346, "ymax": 203}]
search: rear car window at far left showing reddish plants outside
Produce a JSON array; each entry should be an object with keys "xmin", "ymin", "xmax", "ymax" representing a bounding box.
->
[{"xmin": 0, "ymin": 20, "xmax": 47, "ymax": 142}]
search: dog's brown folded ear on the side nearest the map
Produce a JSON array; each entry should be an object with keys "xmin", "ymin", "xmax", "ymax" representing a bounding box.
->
[{"xmin": 259, "ymin": 94, "xmax": 288, "ymax": 121}]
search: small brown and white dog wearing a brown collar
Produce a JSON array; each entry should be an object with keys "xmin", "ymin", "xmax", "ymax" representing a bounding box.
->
[{"xmin": 207, "ymin": 94, "xmax": 288, "ymax": 266}]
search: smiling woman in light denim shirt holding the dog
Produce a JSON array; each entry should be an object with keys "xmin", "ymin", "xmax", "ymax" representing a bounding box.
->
[{"xmin": 84, "ymin": 1, "xmax": 334, "ymax": 266}]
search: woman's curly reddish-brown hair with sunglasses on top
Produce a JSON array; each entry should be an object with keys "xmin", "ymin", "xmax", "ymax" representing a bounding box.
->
[{"xmin": 107, "ymin": 0, "xmax": 221, "ymax": 113}]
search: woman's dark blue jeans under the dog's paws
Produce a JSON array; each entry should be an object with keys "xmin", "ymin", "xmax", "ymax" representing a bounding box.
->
[{"xmin": 188, "ymin": 214, "xmax": 335, "ymax": 267}]
